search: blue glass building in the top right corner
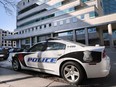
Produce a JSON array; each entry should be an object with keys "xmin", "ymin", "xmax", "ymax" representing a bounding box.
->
[{"xmin": 102, "ymin": 0, "xmax": 116, "ymax": 14}]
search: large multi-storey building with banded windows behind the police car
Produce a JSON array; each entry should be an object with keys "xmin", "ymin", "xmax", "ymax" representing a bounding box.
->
[{"xmin": 6, "ymin": 0, "xmax": 116, "ymax": 48}]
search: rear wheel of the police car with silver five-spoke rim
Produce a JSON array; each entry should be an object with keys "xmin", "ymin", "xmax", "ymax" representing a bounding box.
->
[{"xmin": 61, "ymin": 62, "xmax": 84, "ymax": 85}]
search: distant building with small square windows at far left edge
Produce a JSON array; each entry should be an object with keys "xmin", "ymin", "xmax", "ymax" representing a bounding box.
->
[{"xmin": 0, "ymin": 29, "xmax": 16, "ymax": 48}]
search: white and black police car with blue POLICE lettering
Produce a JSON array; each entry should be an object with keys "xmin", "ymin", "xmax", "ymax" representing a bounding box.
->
[{"xmin": 12, "ymin": 38, "xmax": 110, "ymax": 84}]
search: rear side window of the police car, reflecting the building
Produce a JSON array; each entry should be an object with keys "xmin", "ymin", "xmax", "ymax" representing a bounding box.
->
[{"xmin": 46, "ymin": 42, "xmax": 66, "ymax": 50}]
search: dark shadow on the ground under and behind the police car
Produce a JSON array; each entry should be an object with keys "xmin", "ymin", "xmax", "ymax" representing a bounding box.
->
[{"xmin": 17, "ymin": 64, "xmax": 116, "ymax": 87}]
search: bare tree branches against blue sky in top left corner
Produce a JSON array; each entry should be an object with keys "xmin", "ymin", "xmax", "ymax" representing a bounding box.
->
[{"xmin": 0, "ymin": 0, "xmax": 16, "ymax": 14}]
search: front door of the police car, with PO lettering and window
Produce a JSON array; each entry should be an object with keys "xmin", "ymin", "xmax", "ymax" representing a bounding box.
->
[{"xmin": 24, "ymin": 42, "xmax": 45, "ymax": 68}]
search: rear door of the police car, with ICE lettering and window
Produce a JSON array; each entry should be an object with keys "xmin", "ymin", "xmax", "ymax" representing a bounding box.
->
[{"xmin": 39, "ymin": 42, "xmax": 66, "ymax": 70}]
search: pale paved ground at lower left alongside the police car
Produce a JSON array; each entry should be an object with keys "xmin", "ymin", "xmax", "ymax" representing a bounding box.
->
[{"xmin": 0, "ymin": 61, "xmax": 76, "ymax": 87}]
